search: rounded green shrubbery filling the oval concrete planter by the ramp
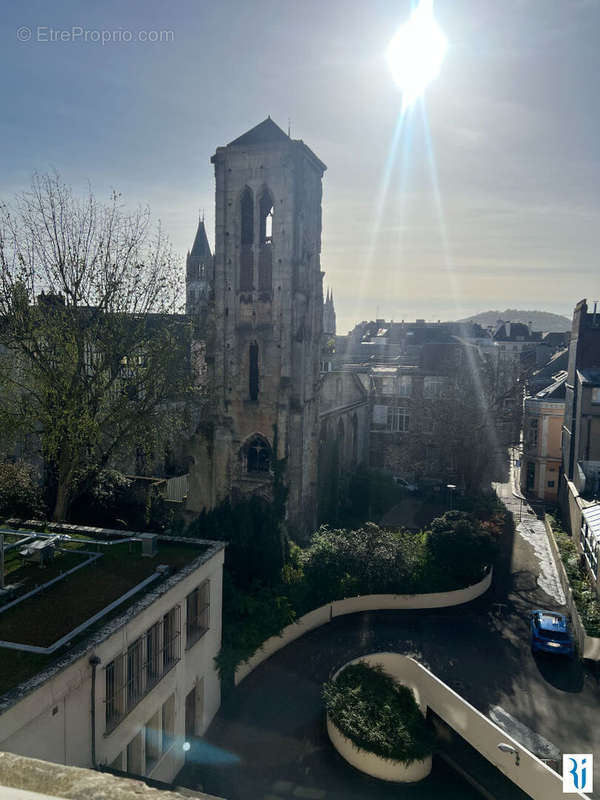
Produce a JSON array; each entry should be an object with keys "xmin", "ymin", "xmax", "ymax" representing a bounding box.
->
[{"xmin": 323, "ymin": 661, "xmax": 435, "ymax": 764}]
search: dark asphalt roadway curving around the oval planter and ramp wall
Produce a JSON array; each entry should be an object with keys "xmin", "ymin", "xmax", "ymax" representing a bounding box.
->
[{"xmin": 180, "ymin": 468, "xmax": 600, "ymax": 800}]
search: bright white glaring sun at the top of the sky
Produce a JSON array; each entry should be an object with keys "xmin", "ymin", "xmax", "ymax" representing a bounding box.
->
[{"xmin": 387, "ymin": 0, "xmax": 448, "ymax": 108}]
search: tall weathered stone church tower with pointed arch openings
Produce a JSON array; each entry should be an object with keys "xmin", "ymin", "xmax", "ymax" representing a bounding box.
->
[{"xmin": 188, "ymin": 117, "xmax": 326, "ymax": 536}]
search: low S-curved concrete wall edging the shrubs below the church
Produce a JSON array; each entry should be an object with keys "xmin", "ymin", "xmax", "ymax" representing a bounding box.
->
[{"xmin": 234, "ymin": 569, "xmax": 493, "ymax": 686}]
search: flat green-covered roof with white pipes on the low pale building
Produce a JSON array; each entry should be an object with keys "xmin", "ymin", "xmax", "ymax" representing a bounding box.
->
[{"xmin": 0, "ymin": 527, "xmax": 224, "ymax": 695}]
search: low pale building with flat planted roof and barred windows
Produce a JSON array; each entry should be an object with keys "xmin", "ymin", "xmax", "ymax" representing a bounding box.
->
[{"xmin": 0, "ymin": 526, "xmax": 225, "ymax": 782}]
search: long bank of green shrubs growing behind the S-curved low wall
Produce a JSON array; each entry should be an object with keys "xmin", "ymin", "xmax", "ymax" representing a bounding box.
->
[{"xmin": 217, "ymin": 511, "xmax": 502, "ymax": 684}]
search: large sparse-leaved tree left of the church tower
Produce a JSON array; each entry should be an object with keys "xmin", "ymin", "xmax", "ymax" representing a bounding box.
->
[{"xmin": 0, "ymin": 174, "xmax": 189, "ymax": 519}]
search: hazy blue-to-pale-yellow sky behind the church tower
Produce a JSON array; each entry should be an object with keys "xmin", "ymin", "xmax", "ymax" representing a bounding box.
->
[{"xmin": 0, "ymin": 0, "xmax": 600, "ymax": 332}]
